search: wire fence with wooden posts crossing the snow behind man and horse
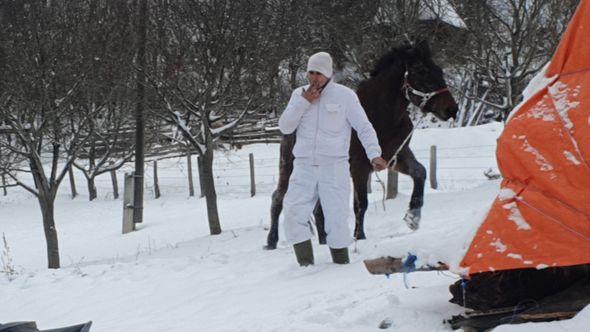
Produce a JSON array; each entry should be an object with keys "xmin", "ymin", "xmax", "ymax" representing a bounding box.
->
[{"xmin": 0, "ymin": 145, "xmax": 499, "ymax": 198}]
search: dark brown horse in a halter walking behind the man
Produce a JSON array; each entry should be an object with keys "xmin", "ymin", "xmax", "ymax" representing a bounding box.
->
[{"xmin": 266, "ymin": 42, "xmax": 457, "ymax": 249}]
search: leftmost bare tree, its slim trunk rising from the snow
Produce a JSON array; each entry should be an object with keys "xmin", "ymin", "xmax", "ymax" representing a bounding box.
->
[{"xmin": 0, "ymin": 1, "xmax": 100, "ymax": 268}]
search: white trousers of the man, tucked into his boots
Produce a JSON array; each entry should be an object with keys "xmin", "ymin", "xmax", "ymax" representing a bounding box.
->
[{"xmin": 283, "ymin": 161, "xmax": 352, "ymax": 249}]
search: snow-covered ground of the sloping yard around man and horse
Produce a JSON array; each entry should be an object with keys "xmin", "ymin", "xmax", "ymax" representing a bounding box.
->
[{"xmin": 0, "ymin": 124, "xmax": 590, "ymax": 332}]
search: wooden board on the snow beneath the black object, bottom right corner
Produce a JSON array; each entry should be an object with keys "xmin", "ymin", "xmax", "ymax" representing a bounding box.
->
[{"xmin": 446, "ymin": 280, "xmax": 590, "ymax": 331}]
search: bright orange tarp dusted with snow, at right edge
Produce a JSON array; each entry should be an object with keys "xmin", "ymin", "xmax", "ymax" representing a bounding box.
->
[{"xmin": 461, "ymin": 0, "xmax": 590, "ymax": 274}]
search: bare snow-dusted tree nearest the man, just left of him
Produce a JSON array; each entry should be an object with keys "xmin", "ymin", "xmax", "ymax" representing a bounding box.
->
[{"xmin": 148, "ymin": 1, "xmax": 261, "ymax": 234}]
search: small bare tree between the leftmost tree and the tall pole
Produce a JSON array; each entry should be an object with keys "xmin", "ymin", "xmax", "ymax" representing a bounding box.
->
[{"xmin": 72, "ymin": 0, "xmax": 134, "ymax": 201}]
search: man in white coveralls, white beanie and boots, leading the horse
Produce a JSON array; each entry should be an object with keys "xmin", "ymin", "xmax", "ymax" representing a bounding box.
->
[{"xmin": 279, "ymin": 52, "xmax": 387, "ymax": 266}]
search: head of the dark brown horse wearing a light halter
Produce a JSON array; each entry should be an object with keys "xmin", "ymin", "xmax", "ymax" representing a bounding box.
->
[{"xmin": 402, "ymin": 42, "xmax": 458, "ymax": 121}]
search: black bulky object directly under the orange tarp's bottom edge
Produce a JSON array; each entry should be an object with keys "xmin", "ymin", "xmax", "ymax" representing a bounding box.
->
[{"xmin": 449, "ymin": 264, "xmax": 590, "ymax": 310}]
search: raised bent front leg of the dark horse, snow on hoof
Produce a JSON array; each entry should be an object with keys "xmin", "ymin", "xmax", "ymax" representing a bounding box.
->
[{"xmin": 395, "ymin": 148, "xmax": 426, "ymax": 230}]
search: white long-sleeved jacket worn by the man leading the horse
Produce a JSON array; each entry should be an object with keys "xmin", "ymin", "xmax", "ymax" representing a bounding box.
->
[{"xmin": 279, "ymin": 81, "xmax": 381, "ymax": 165}]
